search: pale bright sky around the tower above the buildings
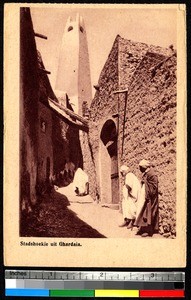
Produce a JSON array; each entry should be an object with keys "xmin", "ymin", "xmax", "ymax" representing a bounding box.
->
[{"xmin": 31, "ymin": 4, "xmax": 177, "ymax": 96}]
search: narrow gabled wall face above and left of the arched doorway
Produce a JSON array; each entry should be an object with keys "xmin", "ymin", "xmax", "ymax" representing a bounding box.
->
[{"xmin": 85, "ymin": 36, "xmax": 119, "ymax": 198}]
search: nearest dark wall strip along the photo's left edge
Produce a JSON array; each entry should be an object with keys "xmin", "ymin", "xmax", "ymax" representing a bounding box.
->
[{"xmin": 20, "ymin": 8, "xmax": 39, "ymax": 212}]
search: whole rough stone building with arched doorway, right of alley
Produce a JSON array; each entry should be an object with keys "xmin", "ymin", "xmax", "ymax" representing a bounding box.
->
[{"xmin": 84, "ymin": 36, "xmax": 176, "ymax": 236}]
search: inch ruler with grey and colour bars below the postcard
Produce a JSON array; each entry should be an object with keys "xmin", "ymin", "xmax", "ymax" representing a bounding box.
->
[{"xmin": 5, "ymin": 270, "xmax": 185, "ymax": 298}]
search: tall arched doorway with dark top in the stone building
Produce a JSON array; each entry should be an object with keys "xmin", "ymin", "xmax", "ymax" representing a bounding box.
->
[{"xmin": 99, "ymin": 119, "xmax": 119, "ymax": 208}]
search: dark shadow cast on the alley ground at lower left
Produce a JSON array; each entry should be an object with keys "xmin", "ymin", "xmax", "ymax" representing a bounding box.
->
[{"xmin": 20, "ymin": 191, "xmax": 105, "ymax": 238}]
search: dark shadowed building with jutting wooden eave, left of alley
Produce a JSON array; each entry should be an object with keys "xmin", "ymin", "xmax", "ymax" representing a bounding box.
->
[{"xmin": 20, "ymin": 8, "xmax": 87, "ymax": 217}]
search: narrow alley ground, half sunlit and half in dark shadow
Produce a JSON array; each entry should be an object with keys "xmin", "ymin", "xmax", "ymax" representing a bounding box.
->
[{"xmin": 21, "ymin": 184, "xmax": 161, "ymax": 238}]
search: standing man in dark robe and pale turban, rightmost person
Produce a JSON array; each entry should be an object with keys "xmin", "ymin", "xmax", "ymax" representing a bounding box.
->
[{"xmin": 135, "ymin": 159, "xmax": 159, "ymax": 237}]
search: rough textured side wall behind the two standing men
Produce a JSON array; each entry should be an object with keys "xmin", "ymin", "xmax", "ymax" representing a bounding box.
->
[{"xmin": 119, "ymin": 52, "xmax": 176, "ymax": 237}]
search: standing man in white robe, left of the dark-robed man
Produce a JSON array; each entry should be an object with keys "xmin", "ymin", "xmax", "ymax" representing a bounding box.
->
[{"xmin": 119, "ymin": 165, "xmax": 141, "ymax": 229}]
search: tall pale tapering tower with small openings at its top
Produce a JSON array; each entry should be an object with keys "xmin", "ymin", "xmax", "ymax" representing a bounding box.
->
[{"xmin": 56, "ymin": 14, "xmax": 92, "ymax": 115}]
